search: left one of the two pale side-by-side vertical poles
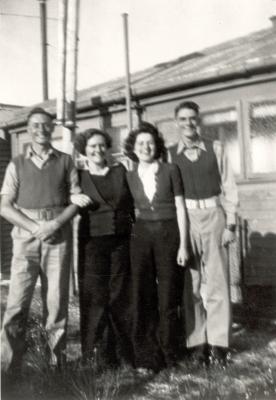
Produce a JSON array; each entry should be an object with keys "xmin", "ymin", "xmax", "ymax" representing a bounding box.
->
[{"xmin": 57, "ymin": 0, "xmax": 67, "ymax": 125}]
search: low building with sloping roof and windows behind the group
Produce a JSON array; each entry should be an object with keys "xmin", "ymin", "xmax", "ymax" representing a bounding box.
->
[{"xmin": 1, "ymin": 17, "xmax": 276, "ymax": 317}]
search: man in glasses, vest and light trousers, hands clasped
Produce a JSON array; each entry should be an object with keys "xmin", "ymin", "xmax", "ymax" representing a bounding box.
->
[{"xmin": 1, "ymin": 108, "xmax": 80, "ymax": 372}]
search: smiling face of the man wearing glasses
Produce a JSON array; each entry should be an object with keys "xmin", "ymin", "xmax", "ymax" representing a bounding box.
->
[{"xmin": 28, "ymin": 113, "xmax": 54, "ymax": 146}]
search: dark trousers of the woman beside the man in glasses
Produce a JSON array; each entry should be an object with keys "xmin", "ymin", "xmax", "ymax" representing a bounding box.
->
[{"xmin": 79, "ymin": 235, "xmax": 132, "ymax": 364}]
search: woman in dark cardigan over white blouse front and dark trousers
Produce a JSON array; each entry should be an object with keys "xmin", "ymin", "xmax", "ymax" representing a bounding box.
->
[{"xmin": 125, "ymin": 122, "xmax": 187, "ymax": 371}]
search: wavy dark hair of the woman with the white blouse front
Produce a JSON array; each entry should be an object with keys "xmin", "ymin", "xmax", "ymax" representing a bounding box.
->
[{"xmin": 124, "ymin": 121, "xmax": 167, "ymax": 162}]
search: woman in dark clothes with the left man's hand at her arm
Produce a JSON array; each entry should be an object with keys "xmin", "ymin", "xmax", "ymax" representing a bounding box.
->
[{"xmin": 72, "ymin": 129, "xmax": 133, "ymax": 368}]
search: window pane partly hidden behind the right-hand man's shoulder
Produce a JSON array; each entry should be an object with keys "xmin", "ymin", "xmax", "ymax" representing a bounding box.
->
[{"xmin": 201, "ymin": 109, "xmax": 241, "ymax": 175}]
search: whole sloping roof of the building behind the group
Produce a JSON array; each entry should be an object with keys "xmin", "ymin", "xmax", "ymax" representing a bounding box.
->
[{"xmin": 0, "ymin": 23, "xmax": 276, "ymax": 127}]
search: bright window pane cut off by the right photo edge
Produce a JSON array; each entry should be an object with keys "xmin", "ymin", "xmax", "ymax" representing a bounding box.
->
[{"xmin": 249, "ymin": 101, "xmax": 276, "ymax": 173}]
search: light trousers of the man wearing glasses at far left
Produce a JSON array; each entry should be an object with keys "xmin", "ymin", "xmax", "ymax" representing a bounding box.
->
[{"xmin": 1, "ymin": 223, "xmax": 72, "ymax": 370}]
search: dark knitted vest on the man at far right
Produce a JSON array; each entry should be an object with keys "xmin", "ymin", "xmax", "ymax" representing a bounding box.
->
[{"xmin": 170, "ymin": 141, "xmax": 221, "ymax": 199}]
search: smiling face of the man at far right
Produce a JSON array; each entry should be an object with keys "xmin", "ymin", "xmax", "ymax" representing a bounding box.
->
[{"xmin": 175, "ymin": 108, "xmax": 199, "ymax": 139}]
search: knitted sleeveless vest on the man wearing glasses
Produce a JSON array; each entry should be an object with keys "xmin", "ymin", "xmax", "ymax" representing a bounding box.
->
[{"xmin": 13, "ymin": 153, "xmax": 70, "ymax": 209}]
